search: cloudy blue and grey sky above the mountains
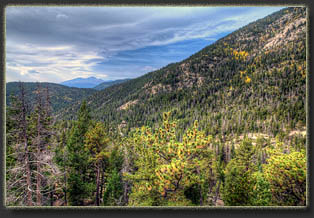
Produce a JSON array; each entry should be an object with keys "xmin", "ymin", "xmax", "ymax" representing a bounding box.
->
[{"xmin": 5, "ymin": 6, "xmax": 282, "ymax": 83}]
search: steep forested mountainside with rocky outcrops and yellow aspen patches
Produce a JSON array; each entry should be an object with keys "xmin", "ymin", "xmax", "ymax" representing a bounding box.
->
[{"xmin": 60, "ymin": 7, "xmax": 306, "ymax": 137}]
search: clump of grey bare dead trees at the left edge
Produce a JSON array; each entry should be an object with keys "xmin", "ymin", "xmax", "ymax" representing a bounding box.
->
[{"xmin": 6, "ymin": 83, "xmax": 58, "ymax": 206}]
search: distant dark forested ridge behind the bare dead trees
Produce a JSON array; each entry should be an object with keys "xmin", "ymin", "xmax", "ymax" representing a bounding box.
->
[{"xmin": 6, "ymin": 82, "xmax": 96, "ymax": 113}]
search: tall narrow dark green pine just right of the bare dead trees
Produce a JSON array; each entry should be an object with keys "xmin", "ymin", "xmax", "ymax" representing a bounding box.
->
[{"xmin": 67, "ymin": 101, "xmax": 91, "ymax": 206}]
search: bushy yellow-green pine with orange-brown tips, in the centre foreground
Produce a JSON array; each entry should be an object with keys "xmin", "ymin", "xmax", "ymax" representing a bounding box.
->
[{"xmin": 128, "ymin": 113, "xmax": 212, "ymax": 204}]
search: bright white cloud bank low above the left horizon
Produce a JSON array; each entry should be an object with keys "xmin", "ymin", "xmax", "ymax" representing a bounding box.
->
[{"xmin": 6, "ymin": 44, "xmax": 105, "ymax": 83}]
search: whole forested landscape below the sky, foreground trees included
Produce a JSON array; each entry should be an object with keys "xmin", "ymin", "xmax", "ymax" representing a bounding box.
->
[{"xmin": 6, "ymin": 7, "xmax": 307, "ymax": 206}]
